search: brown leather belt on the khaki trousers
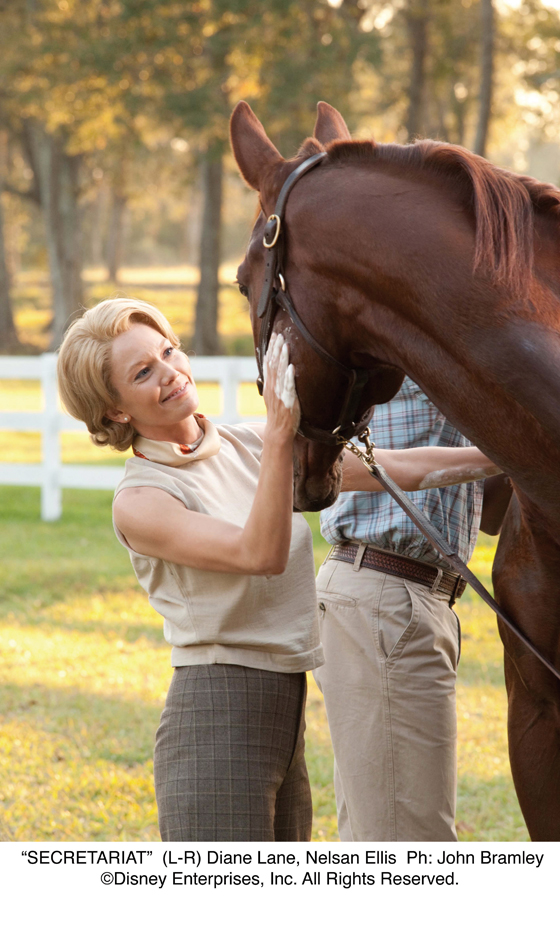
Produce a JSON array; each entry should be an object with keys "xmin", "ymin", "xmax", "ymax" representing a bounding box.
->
[{"xmin": 328, "ymin": 543, "xmax": 467, "ymax": 607}]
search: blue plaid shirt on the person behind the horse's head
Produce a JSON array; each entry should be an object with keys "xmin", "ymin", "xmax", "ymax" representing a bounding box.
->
[{"xmin": 321, "ymin": 377, "xmax": 483, "ymax": 564}]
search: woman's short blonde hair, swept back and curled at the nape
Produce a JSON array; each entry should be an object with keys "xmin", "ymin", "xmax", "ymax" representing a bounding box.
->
[{"xmin": 57, "ymin": 298, "xmax": 180, "ymax": 450}]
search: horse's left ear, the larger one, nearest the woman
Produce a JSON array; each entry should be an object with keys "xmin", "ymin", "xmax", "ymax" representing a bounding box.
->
[{"xmin": 229, "ymin": 101, "xmax": 284, "ymax": 192}]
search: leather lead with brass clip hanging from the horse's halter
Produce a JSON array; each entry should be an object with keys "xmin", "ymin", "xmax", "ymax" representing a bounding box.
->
[{"xmin": 340, "ymin": 428, "xmax": 560, "ymax": 681}]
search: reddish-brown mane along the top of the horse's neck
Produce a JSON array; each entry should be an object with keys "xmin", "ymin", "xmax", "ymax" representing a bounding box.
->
[{"xmin": 305, "ymin": 139, "xmax": 560, "ymax": 297}]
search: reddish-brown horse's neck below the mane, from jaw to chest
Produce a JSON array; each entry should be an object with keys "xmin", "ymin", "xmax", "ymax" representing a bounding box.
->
[{"xmin": 302, "ymin": 171, "xmax": 560, "ymax": 525}]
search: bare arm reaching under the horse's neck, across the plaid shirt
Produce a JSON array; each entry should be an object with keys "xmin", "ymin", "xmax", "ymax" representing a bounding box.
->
[{"xmin": 342, "ymin": 447, "xmax": 501, "ymax": 492}]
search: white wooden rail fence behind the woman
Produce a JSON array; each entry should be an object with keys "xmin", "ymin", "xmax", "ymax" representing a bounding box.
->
[{"xmin": 0, "ymin": 354, "xmax": 257, "ymax": 521}]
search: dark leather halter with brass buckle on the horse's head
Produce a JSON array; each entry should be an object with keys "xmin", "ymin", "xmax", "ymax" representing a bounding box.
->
[{"xmin": 256, "ymin": 151, "xmax": 370, "ymax": 444}]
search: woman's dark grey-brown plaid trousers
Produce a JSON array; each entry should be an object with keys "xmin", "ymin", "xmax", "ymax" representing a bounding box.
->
[{"xmin": 154, "ymin": 664, "xmax": 312, "ymax": 842}]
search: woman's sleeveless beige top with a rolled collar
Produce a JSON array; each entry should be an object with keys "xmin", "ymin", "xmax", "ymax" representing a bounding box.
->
[{"xmin": 115, "ymin": 418, "xmax": 323, "ymax": 672}]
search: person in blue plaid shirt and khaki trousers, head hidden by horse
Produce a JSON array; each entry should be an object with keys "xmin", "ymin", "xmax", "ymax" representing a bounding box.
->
[{"xmin": 315, "ymin": 378, "xmax": 490, "ymax": 841}]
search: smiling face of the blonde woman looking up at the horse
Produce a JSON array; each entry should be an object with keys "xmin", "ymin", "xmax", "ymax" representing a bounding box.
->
[{"xmin": 107, "ymin": 324, "xmax": 198, "ymax": 438}]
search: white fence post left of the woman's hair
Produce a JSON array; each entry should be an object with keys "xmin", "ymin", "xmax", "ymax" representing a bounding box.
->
[{"xmin": 41, "ymin": 354, "xmax": 62, "ymax": 521}]
